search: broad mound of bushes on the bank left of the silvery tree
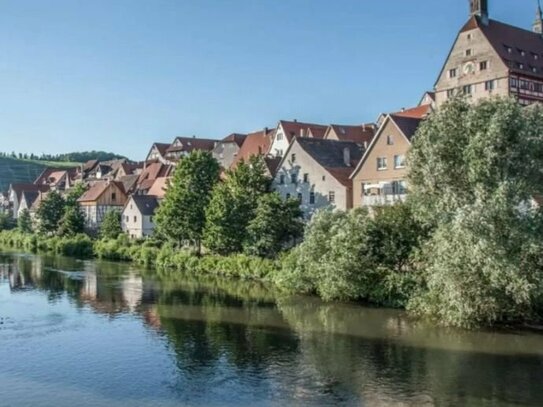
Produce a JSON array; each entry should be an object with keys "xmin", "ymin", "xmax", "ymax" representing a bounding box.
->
[{"xmin": 274, "ymin": 204, "xmax": 421, "ymax": 306}]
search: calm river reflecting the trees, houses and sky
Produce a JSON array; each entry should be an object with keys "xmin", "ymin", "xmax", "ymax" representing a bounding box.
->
[{"xmin": 0, "ymin": 253, "xmax": 543, "ymax": 407}]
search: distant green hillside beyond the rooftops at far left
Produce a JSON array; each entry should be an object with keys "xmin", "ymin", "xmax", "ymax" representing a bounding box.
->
[{"xmin": 0, "ymin": 157, "xmax": 78, "ymax": 192}]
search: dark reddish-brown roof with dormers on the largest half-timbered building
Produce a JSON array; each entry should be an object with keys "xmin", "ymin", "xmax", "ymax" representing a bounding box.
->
[{"xmin": 460, "ymin": 16, "xmax": 543, "ymax": 78}]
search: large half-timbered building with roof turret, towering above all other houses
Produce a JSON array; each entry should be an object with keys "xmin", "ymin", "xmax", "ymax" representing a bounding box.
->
[{"xmin": 435, "ymin": 0, "xmax": 543, "ymax": 107}]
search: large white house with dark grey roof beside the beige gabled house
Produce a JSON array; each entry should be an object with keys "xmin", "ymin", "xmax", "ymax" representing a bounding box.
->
[{"xmin": 272, "ymin": 137, "xmax": 364, "ymax": 219}]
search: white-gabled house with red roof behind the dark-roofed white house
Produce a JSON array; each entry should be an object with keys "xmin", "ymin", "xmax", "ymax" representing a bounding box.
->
[{"xmin": 267, "ymin": 120, "xmax": 328, "ymax": 157}]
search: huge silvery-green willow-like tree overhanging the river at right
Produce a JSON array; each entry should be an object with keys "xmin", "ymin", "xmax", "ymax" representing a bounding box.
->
[{"xmin": 409, "ymin": 99, "xmax": 543, "ymax": 327}]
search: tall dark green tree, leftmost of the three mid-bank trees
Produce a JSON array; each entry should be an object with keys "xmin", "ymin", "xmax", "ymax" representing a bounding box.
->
[{"xmin": 155, "ymin": 150, "xmax": 220, "ymax": 251}]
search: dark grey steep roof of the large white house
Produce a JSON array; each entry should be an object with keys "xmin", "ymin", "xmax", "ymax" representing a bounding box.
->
[{"xmin": 298, "ymin": 137, "xmax": 364, "ymax": 186}]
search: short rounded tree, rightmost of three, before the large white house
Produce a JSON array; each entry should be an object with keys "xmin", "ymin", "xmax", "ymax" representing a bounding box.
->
[{"xmin": 244, "ymin": 192, "xmax": 304, "ymax": 258}]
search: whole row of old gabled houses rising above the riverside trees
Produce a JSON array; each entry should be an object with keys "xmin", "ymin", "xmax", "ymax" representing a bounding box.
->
[{"xmin": 5, "ymin": 1, "xmax": 543, "ymax": 237}]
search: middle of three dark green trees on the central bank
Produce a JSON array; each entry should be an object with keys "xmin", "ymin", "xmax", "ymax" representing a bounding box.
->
[{"xmin": 204, "ymin": 156, "xmax": 271, "ymax": 254}]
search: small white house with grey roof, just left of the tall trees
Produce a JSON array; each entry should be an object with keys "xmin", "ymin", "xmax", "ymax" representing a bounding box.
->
[{"xmin": 121, "ymin": 195, "xmax": 158, "ymax": 239}]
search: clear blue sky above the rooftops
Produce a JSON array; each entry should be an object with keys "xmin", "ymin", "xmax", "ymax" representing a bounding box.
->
[{"xmin": 0, "ymin": 0, "xmax": 536, "ymax": 159}]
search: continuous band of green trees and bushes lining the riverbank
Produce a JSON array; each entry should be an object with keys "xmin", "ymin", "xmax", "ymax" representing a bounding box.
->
[{"xmin": 0, "ymin": 99, "xmax": 543, "ymax": 328}]
